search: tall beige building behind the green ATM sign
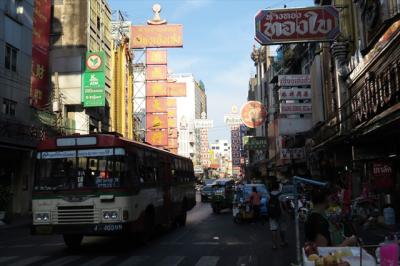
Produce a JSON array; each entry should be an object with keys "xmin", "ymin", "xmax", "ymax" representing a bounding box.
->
[{"xmin": 50, "ymin": 0, "xmax": 113, "ymax": 134}]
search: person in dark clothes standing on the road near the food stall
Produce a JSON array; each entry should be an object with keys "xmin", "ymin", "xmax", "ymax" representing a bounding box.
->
[{"xmin": 268, "ymin": 182, "xmax": 288, "ymax": 249}]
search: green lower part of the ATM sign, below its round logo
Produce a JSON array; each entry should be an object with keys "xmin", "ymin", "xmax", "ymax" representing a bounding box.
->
[{"xmin": 82, "ymin": 72, "xmax": 106, "ymax": 107}]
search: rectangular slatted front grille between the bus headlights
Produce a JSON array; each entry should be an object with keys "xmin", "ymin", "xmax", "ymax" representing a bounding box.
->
[{"xmin": 53, "ymin": 206, "xmax": 99, "ymax": 224}]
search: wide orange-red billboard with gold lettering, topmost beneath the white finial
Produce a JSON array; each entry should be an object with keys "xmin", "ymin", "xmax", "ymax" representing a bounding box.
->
[{"xmin": 130, "ymin": 24, "xmax": 183, "ymax": 49}]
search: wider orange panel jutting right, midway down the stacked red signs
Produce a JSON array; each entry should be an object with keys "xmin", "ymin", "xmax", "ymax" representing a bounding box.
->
[{"xmin": 146, "ymin": 82, "xmax": 186, "ymax": 97}]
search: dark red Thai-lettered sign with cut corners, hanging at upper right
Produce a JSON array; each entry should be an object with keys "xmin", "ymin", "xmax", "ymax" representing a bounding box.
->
[{"xmin": 255, "ymin": 6, "xmax": 340, "ymax": 45}]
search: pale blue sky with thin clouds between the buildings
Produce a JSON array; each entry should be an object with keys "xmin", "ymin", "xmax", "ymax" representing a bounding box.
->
[{"xmin": 109, "ymin": 0, "xmax": 313, "ymax": 142}]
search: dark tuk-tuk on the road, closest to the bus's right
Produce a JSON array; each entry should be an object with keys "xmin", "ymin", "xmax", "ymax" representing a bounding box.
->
[{"xmin": 211, "ymin": 178, "xmax": 235, "ymax": 214}]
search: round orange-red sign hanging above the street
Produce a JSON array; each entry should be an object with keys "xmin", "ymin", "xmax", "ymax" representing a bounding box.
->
[{"xmin": 240, "ymin": 101, "xmax": 267, "ymax": 128}]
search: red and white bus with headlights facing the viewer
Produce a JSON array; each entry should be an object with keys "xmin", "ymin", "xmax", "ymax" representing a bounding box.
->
[{"xmin": 32, "ymin": 134, "xmax": 196, "ymax": 247}]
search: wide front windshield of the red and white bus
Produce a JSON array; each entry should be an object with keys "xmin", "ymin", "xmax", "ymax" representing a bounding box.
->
[{"xmin": 34, "ymin": 156, "xmax": 126, "ymax": 191}]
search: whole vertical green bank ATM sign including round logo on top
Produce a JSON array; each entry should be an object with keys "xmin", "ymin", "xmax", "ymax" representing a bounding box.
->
[{"xmin": 82, "ymin": 51, "xmax": 106, "ymax": 107}]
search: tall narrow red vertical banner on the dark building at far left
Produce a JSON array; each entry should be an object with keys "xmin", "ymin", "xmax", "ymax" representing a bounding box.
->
[{"xmin": 30, "ymin": 0, "xmax": 51, "ymax": 108}]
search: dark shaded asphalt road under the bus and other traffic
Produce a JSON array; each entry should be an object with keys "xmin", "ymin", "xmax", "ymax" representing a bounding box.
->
[{"xmin": 0, "ymin": 196, "xmax": 295, "ymax": 266}]
